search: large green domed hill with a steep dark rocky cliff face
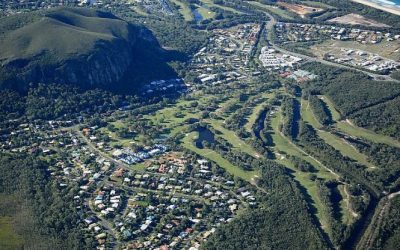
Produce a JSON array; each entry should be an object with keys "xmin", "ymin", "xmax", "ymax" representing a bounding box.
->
[{"xmin": 0, "ymin": 8, "xmax": 178, "ymax": 90}]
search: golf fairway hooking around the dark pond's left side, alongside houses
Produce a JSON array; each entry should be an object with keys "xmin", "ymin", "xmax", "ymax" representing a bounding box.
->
[{"xmin": 182, "ymin": 132, "xmax": 260, "ymax": 182}]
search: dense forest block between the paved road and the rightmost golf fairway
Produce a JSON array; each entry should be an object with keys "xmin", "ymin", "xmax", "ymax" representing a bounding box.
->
[{"xmin": 305, "ymin": 63, "xmax": 400, "ymax": 138}]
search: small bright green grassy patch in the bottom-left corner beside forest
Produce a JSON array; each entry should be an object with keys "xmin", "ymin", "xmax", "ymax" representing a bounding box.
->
[{"xmin": 0, "ymin": 216, "xmax": 24, "ymax": 250}]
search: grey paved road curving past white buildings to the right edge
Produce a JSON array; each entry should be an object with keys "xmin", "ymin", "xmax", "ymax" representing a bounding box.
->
[{"xmin": 266, "ymin": 13, "xmax": 400, "ymax": 83}]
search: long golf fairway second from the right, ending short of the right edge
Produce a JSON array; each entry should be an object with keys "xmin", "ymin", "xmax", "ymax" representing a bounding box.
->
[{"xmin": 301, "ymin": 100, "xmax": 376, "ymax": 169}]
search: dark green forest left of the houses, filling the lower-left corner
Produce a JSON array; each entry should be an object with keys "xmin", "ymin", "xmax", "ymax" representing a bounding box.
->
[{"xmin": 0, "ymin": 154, "xmax": 92, "ymax": 249}]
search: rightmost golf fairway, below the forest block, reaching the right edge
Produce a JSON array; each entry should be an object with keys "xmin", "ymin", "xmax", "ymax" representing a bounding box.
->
[{"xmin": 321, "ymin": 96, "xmax": 400, "ymax": 147}]
